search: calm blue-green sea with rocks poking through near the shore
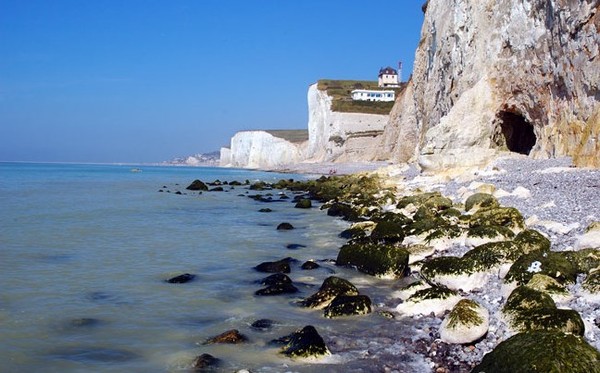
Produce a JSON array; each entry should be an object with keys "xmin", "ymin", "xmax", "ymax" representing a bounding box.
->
[{"xmin": 0, "ymin": 163, "xmax": 422, "ymax": 372}]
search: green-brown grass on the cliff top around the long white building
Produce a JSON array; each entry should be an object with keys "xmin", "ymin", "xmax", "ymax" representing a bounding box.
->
[{"xmin": 317, "ymin": 79, "xmax": 405, "ymax": 115}]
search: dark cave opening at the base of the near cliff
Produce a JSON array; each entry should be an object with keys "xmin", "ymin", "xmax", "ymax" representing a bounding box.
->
[{"xmin": 498, "ymin": 111, "xmax": 537, "ymax": 155}]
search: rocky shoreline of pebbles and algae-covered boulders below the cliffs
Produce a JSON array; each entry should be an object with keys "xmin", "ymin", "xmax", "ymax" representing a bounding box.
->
[{"xmin": 180, "ymin": 157, "xmax": 600, "ymax": 372}]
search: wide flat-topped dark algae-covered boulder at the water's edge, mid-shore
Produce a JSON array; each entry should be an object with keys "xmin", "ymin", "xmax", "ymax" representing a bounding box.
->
[{"xmin": 336, "ymin": 243, "xmax": 408, "ymax": 278}]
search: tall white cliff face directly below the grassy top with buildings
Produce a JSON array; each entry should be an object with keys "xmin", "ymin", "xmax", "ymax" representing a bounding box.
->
[{"xmin": 306, "ymin": 84, "xmax": 389, "ymax": 162}]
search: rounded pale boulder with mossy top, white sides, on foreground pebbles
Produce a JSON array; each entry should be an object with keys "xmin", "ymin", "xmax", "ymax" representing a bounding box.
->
[{"xmin": 439, "ymin": 299, "xmax": 490, "ymax": 344}]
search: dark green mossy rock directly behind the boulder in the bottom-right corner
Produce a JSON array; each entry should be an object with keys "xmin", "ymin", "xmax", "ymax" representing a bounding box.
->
[{"xmin": 502, "ymin": 286, "xmax": 585, "ymax": 335}]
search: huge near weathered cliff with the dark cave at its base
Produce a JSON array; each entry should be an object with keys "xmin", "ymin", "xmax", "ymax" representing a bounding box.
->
[{"xmin": 380, "ymin": 0, "xmax": 600, "ymax": 169}]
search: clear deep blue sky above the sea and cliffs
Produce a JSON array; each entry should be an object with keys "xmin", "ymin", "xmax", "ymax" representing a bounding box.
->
[{"xmin": 0, "ymin": 0, "xmax": 424, "ymax": 162}]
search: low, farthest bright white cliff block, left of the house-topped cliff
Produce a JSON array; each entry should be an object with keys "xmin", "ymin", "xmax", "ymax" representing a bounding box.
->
[{"xmin": 221, "ymin": 131, "xmax": 306, "ymax": 169}]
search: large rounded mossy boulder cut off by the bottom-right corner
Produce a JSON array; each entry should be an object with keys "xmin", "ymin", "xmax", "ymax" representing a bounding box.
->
[{"xmin": 472, "ymin": 331, "xmax": 600, "ymax": 373}]
